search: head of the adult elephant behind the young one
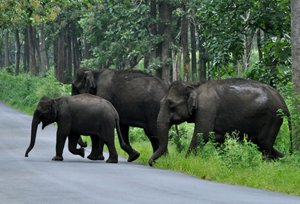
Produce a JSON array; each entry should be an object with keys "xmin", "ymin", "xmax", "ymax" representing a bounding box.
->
[{"xmin": 72, "ymin": 69, "xmax": 96, "ymax": 95}]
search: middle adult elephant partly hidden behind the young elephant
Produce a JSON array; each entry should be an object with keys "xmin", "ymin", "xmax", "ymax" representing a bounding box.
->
[{"xmin": 72, "ymin": 69, "xmax": 167, "ymax": 162}]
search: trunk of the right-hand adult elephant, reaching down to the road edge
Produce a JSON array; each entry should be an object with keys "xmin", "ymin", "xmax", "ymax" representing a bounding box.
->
[{"xmin": 148, "ymin": 123, "xmax": 170, "ymax": 166}]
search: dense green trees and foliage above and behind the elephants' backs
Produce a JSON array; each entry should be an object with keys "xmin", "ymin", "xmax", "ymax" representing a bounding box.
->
[{"xmin": 0, "ymin": 0, "xmax": 291, "ymax": 82}]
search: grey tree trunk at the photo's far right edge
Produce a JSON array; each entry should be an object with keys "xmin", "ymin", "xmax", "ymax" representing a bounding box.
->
[{"xmin": 291, "ymin": 0, "xmax": 300, "ymax": 150}]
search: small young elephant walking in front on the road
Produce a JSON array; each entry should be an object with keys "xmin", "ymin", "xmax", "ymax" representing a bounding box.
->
[{"xmin": 25, "ymin": 94, "xmax": 131, "ymax": 163}]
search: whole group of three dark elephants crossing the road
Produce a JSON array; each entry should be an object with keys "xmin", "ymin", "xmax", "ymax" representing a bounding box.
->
[{"xmin": 25, "ymin": 69, "xmax": 290, "ymax": 166}]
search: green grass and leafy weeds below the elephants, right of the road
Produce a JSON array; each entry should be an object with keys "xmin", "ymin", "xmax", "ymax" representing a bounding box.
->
[{"xmin": 117, "ymin": 124, "xmax": 300, "ymax": 195}]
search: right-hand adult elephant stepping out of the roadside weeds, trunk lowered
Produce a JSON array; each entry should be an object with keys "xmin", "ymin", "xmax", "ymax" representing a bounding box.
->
[{"xmin": 148, "ymin": 78, "xmax": 291, "ymax": 166}]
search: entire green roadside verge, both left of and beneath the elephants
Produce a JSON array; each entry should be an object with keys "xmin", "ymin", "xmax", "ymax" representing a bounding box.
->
[{"xmin": 0, "ymin": 72, "xmax": 300, "ymax": 195}]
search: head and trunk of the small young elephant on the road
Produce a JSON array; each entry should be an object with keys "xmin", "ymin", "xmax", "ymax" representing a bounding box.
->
[{"xmin": 25, "ymin": 97, "xmax": 58, "ymax": 157}]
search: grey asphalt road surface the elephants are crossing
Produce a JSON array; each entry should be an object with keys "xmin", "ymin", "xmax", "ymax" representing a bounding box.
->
[{"xmin": 0, "ymin": 102, "xmax": 300, "ymax": 204}]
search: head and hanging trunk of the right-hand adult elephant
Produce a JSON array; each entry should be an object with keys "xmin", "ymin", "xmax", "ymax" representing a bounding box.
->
[{"xmin": 149, "ymin": 81, "xmax": 197, "ymax": 166}]
